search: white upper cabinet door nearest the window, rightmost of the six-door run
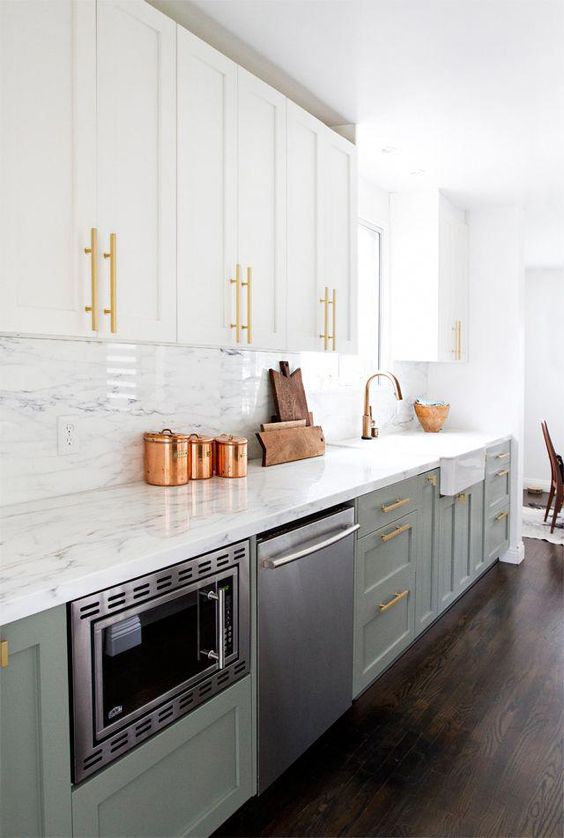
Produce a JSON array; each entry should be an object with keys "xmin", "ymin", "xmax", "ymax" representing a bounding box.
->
[{"xmin": 322, "ymin": 130, "xmax": 358, "ymax": 354}]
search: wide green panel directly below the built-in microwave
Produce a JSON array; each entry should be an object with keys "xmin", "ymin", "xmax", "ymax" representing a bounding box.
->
[{"xmin": 72, "ymin": 677, "xmax": 255, "ymax": 838}]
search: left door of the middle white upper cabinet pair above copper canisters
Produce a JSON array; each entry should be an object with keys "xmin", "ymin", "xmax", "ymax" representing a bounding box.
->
[{"xmin": 177, "ymin": 26, "xmax": 237, "ymax": 346}]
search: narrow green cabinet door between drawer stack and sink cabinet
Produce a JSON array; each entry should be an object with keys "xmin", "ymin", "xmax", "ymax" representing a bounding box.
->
[{"xmin": 415, "ymin": 469, "xmax": 440, "ymax": 635}]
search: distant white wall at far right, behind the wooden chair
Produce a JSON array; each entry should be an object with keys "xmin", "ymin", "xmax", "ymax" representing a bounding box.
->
[{"xmin": 525, "ymin": 268, "xmax": 564, "ymax": 489}]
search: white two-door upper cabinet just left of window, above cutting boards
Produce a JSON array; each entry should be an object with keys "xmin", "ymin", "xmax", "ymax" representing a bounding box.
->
[{"xmin": 287, "ymin": 102, "xmax": 357, "ymax": 352}]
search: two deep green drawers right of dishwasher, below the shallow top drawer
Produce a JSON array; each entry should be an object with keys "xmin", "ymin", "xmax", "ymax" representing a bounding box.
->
[{"xmin": 354, "ymin": 512, "xmax": 418, "ymax": 695}]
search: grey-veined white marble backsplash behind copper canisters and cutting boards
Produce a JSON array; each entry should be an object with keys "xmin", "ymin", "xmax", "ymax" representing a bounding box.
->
[{"xmin": 0, "ymin": 337, "xmax": 427, "ymax": 506}]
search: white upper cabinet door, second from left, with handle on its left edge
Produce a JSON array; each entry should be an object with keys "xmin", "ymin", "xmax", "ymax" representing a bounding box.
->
[{"xmin": 97, "ymin": 0, "xmax": 176, "ymax": 341}]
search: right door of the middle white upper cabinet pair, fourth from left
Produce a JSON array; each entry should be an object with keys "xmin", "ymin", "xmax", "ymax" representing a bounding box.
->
[{"xmin": 237, "ymin": 67, "xmax": 286, "ymax": 349}]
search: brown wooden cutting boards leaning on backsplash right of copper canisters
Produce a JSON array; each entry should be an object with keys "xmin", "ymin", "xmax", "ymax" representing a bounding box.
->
[{"xmin": 257, "ymin": 361, "xmax": 325, "ymax": 466}]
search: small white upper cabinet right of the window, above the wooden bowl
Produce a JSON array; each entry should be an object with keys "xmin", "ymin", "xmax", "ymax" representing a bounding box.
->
[{"xmin": 391, "ymin": 190, "xmax": 468, "ymax": 361}]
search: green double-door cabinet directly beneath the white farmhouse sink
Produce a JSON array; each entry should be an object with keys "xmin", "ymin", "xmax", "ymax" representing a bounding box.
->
[{"xmin": 438, "ymin": 482, "xmax": 484, "ymax": 611}]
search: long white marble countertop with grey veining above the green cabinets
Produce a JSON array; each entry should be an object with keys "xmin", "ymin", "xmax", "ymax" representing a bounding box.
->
[{"xmin": 0, "ymin": 431, "xmax": 509, "ymax": 625}]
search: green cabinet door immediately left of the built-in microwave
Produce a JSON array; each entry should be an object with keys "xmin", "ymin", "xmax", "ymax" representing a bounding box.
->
[{"xmin": 0, "ymin": 606, "xmax": 72, "ymax": 838}]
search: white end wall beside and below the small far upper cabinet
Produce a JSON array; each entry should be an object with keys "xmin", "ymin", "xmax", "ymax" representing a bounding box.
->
[{"xmin": 428, "ymin": 207, "xmax": 525, "ymax": 562}]
